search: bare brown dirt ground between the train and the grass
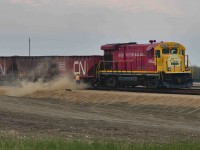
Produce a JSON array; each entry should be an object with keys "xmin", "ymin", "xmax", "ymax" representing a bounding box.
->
[{"xmin": 0, "ymin": 80, "xmax": 200, "ymax": 148}]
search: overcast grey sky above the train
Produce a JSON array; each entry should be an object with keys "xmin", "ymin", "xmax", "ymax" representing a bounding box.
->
[{"xmin": 0, "ymin": 0, "xmax": 200, "ymax": 66}]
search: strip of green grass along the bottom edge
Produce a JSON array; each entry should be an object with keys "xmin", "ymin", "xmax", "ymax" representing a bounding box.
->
[{"xmin": 0, "ymin": 137, "xmax": 200, "ymax": 150}]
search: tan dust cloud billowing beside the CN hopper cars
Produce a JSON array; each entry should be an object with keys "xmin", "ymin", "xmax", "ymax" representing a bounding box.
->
[{"xmin": 1, "ymin": 77, "xmax": 87, "ymax": 97}]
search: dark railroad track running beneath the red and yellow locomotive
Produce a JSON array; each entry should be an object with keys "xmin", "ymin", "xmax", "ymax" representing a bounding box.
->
[{"xmin": 88, "ymin": 87, "xmax": 200, "ymax": 95}]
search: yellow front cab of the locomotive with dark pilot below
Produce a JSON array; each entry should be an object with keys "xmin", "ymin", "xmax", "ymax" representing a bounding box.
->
[{"xmin": 154, "ymin": 42, "xmax": 192, "ymax": 88}]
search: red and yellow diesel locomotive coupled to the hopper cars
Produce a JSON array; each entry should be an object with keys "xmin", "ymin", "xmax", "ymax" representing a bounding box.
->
[{"xmin": 97, "ymin": 40, "xmax": 193, "ymax": 88}]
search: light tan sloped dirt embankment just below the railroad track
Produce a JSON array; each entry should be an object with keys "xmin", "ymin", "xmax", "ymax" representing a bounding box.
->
[{"xmin": 26, "ymin": 90, "xmax": 200, "ymax": 108}]
